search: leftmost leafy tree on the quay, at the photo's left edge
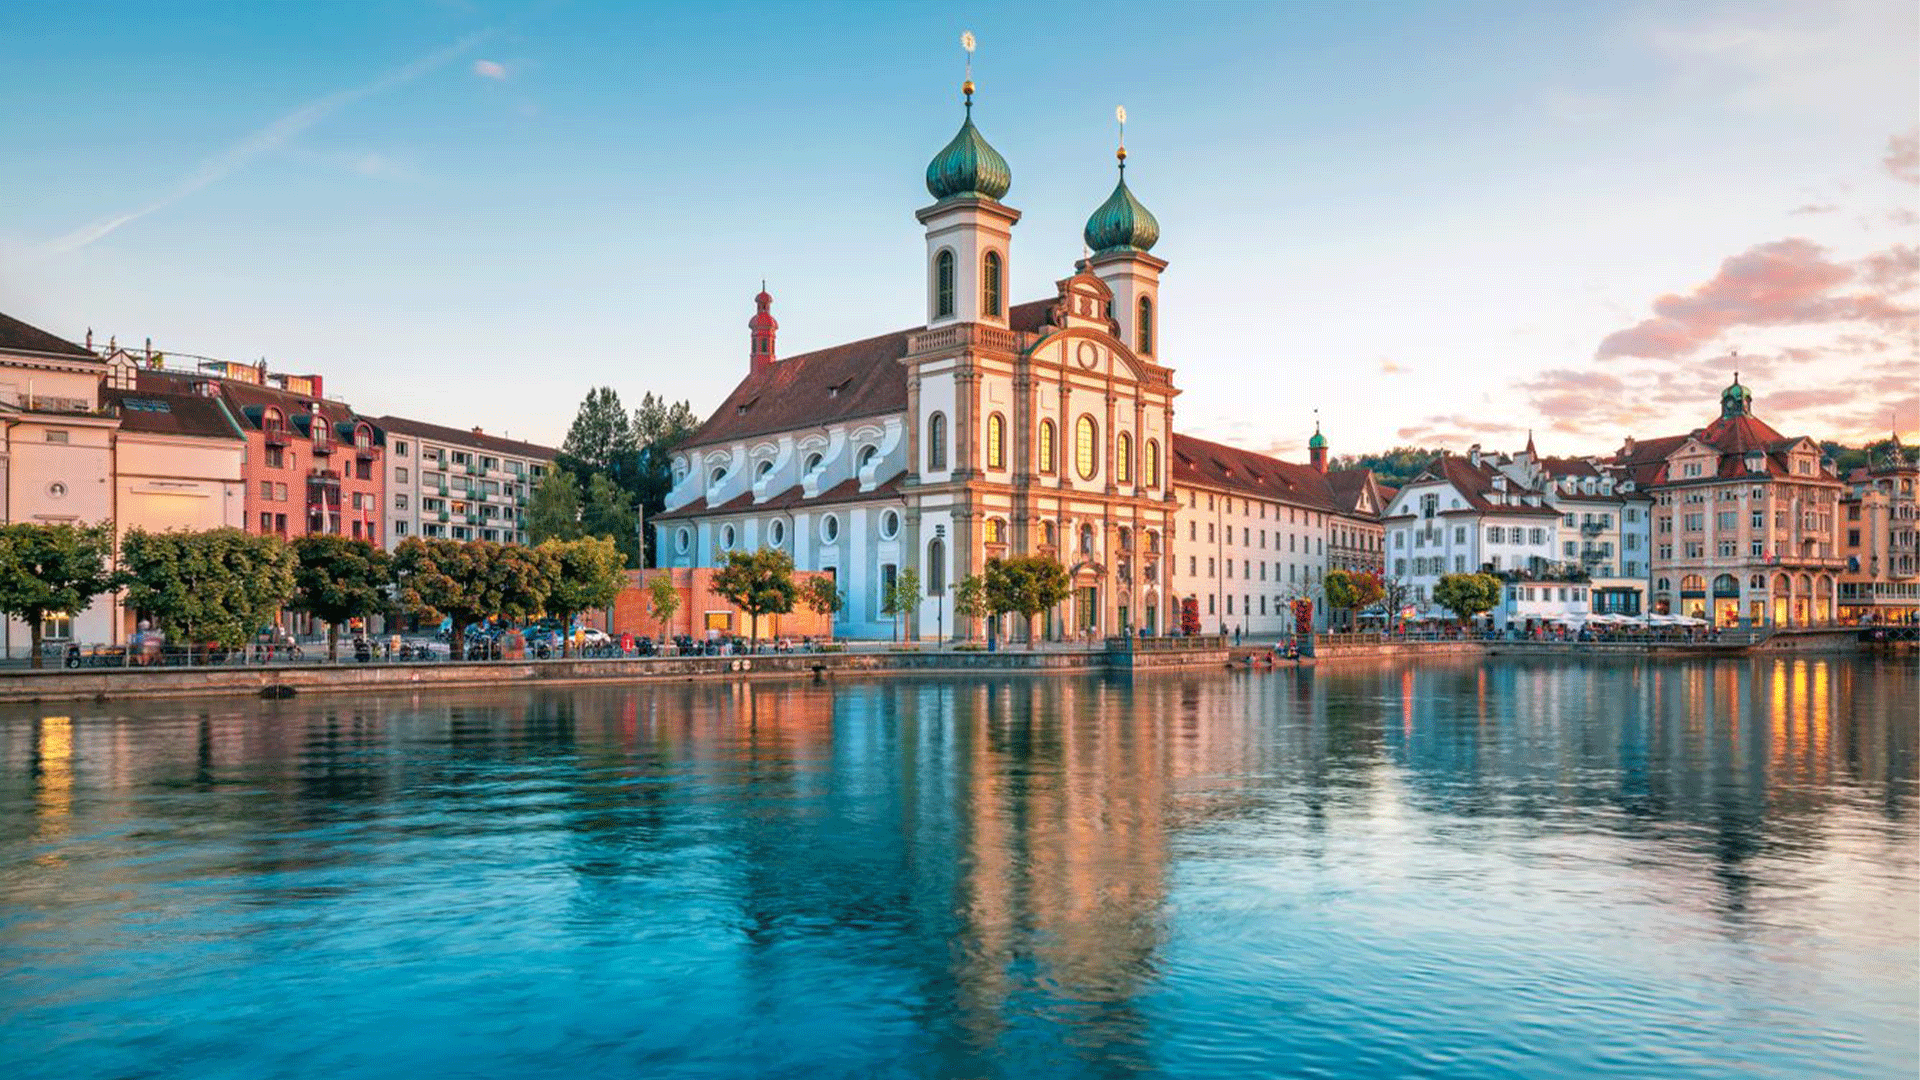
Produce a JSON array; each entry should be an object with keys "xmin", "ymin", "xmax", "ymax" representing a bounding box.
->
[{"xmin": 0, "ymin": 521, "xmax": 121, "ymax": 667}]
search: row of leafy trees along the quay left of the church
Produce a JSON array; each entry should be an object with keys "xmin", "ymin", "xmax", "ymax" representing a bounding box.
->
[{"xmin": 0, "ymin": 523, "xmax": 626, "ymax": 667}]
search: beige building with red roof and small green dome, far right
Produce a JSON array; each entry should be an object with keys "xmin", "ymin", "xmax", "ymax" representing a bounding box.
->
[{"xmin": 1613, "ymin": 375, "xmax": 1847, "ymax": 626}]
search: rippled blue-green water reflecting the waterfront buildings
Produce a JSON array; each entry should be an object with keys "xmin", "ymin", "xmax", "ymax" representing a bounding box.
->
[{"xmin": 0, "ymin": 659, "xmax": 1920, "ymax": 1080}]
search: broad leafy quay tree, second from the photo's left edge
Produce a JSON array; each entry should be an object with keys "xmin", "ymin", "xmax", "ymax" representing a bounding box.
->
[{"xmin": 121, "ymin": 528, "xmax": 296, "ymax": 650}]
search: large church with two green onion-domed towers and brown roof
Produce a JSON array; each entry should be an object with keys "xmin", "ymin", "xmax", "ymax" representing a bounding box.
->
[{"xmin": 653, "ymin": 81, "xmax": 1179, "ymax": 640}]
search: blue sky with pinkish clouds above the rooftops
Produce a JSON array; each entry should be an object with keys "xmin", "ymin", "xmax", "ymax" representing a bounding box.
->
[{"xmin": 0, "ymin": 0, "xmax": 1920, "ymax": 455}]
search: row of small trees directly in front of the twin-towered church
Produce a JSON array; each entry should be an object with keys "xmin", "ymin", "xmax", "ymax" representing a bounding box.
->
[{"xmin": 710, "ymin": 548, "xmax": 1071, "ymax": 642}]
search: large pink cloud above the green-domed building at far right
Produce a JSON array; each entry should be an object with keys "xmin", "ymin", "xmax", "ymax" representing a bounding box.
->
[{"xmin": 1596, "ymin": 236, "xmax": 1914, "ymax": 359}]
